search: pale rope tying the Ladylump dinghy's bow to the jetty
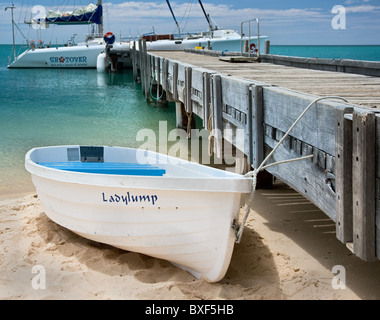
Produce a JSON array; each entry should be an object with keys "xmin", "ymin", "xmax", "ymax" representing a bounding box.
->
[{"xmin": 232, "ymin": 96, "xmax": 348, "ymax": 243}]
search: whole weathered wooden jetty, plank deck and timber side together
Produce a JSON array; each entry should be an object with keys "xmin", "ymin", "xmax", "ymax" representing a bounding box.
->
[{"xmin": 131, "ymin": 41, "xmax": 380, "ymax": 261}]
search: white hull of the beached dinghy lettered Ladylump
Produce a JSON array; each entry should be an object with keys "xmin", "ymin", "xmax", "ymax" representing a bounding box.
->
[{"xmin": 26, "ymin": 147, "xmax": 250, "ymax": 282}]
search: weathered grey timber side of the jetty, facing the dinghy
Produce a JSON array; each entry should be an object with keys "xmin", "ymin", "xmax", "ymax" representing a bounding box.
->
[{"xmin": 131, "ymin": 41, "xmax": 380, "ymax": 261}]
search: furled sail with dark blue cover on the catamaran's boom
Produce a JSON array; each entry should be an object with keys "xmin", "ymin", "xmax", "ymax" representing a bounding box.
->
[{"xmin": 29, "ymin": 4, "xmax": 103, "ymax": 25}]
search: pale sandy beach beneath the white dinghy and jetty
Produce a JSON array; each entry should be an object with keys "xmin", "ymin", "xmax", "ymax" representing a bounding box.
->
[{"xmin": 0, "ymin": 183, "xmax": 380, "ymax": 300}]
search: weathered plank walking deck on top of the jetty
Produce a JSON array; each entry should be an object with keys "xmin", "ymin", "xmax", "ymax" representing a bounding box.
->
[{"xmin": 152, "ymin": 51, "xmax": 380, "ymax": 110}]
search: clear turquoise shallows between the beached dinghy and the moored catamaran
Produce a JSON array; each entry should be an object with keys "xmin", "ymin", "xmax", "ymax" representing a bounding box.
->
[{"xmin": 0, "ymin": 45, "xmax": 175, "ymax": 193}]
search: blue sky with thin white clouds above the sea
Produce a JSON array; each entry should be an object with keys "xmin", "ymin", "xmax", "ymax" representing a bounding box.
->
[{"xmin": 0, "ymin": 0, "xmax": 380, "ymax": 45}]
